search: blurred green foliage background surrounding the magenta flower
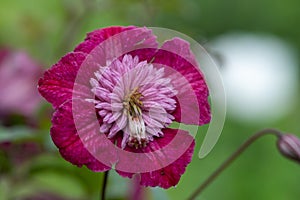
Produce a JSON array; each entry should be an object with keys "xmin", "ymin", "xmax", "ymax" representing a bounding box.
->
[{"xmin": 0, "ymin": 0, "xmax": 300, "ymax": 200}]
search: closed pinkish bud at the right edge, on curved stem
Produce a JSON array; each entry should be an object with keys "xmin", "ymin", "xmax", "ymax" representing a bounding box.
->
[{"xmin": 277, "ymin": 134, "xmax": 300, "ymax": 163}]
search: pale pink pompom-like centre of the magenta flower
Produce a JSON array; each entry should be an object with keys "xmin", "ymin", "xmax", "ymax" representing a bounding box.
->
[{"xmin": 88, "ymin": 55, "xmax": 177, "ymax": 148}]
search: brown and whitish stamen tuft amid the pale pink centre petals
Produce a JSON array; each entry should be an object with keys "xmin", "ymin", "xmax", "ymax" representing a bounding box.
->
[{"xmin": 124, "ymin": 88, "xmax": 149, "ymax": 149}]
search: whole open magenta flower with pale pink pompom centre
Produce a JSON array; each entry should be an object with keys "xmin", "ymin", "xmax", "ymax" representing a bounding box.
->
[{"xmin": 38, "ymin": 26, "xmax": 210, "ymax": 188}]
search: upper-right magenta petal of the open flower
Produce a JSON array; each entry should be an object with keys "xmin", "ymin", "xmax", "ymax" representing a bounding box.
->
[{"xmin": 153, "ymin": 38, "xmax": 211, "ymax": 125}]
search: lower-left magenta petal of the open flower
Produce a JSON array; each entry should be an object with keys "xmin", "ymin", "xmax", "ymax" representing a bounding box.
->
[{"xmin": 51, "ymin": 100, "xmax": 110, "ymax": 171}]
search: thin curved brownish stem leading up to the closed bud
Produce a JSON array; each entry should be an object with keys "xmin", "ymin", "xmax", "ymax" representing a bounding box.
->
[{"xmin": 188, "ymin": 129, "xmax": 282, "ymax": 200}]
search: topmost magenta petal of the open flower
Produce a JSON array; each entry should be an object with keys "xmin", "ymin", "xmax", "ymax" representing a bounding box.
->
[{"xmin": 75, "ymin": 26, "xmax": 158, "ymax": 66}]
